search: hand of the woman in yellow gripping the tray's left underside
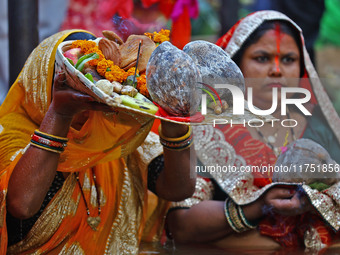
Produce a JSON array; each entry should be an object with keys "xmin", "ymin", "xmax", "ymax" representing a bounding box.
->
[{"xmin": 50, "ymin": 73, "xmax": 113, "ymax": 118}]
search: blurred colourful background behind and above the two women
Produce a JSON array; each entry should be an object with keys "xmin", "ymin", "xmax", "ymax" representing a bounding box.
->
[{"xmin": 0, "ymin": 0, "xmax": 340, "ymax": 112}]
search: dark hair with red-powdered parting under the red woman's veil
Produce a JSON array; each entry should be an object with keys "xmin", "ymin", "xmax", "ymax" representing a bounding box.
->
[{"xmin": 232, "ymin": 20, "xmax": 304, "ymax": 77}]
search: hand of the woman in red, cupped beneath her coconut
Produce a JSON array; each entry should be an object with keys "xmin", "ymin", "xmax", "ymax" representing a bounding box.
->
[{"xmin": 263, "ymin": 187, "xmax": 313, "ymax": 216}]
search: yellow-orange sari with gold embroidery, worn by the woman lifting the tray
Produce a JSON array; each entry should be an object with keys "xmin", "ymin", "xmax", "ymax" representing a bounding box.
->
[{"xmin": 0, "ymin": 30, "xmax": 167, "ymax": 254}]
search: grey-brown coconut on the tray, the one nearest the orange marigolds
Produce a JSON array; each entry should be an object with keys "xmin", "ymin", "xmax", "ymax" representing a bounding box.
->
[{"xmin": 146, "ymin": 42, "xmax": 202, "ymax": 116}]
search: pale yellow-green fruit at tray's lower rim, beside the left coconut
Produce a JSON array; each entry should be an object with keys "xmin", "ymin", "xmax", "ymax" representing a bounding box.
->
[{"xmin": 120, "ymin": 93, "xmax": 158, "ymax": 114}]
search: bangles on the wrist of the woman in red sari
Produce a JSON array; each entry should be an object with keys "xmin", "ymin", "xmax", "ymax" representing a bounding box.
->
[{"xmin": 224, "ymin": 198, "xmax": 257, "ymax": 233}]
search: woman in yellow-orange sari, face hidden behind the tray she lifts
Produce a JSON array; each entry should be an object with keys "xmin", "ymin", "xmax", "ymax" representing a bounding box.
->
[{"xmin": 0, "ymin": 30, "xmax": 195, "ymax": 254}]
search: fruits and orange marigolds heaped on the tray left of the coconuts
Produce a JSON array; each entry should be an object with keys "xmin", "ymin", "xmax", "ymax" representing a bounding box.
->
[{"xmin": 63, "ymin": 29, "xmax": 170, "ymax": 114}]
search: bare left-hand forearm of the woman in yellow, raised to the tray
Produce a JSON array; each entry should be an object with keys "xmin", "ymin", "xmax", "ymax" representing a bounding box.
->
[{"xmin": 7, "ymin": 104, "xmax": 72, "ymax": 219}]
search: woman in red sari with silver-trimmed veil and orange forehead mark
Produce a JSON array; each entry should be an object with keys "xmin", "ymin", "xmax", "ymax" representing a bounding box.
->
[{"xmin": 167, "ymin": 11, "xmax": 340, "ymax": 250}]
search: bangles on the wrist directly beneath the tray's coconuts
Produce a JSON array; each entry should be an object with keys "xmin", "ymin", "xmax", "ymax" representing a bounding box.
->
[{"xmin": 158, "ymin": 126, "xmax": 193, "ymax": 151}]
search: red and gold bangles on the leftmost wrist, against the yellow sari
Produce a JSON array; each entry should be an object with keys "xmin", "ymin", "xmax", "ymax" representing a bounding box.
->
[{"xmin": 30, "ymin": 129, "xmax": 68, "ymax": 153}]
